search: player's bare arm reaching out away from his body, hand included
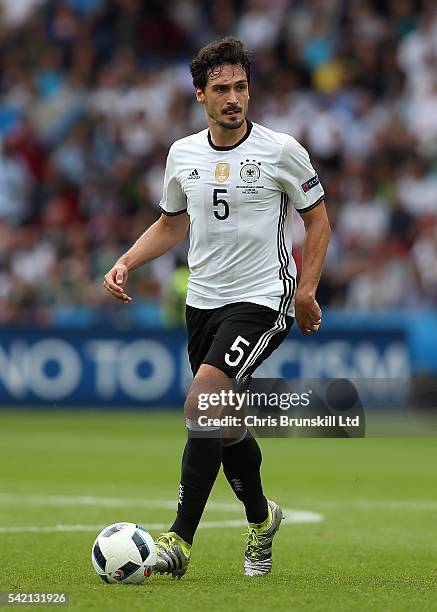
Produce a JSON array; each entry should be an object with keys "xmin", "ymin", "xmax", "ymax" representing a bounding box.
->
[{"xmin": 103, "ymin": 212, "xmax": 190, "ymax": 304}]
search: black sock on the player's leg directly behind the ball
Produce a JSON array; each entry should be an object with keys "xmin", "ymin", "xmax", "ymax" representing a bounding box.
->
[{"xmin": 170, "ymin": 431, "xmax": 222, "ymax": 544}]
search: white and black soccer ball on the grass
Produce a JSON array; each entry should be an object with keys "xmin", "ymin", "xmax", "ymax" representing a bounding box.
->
[{"xmin": 91, "ymin": 523, "xmax": 156, "ymax": 584}]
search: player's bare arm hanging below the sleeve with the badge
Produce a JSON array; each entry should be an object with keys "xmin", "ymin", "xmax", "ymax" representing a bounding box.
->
[{"xmin": 295, "ymin": 201, "xmax": 331, "ymax": 335}]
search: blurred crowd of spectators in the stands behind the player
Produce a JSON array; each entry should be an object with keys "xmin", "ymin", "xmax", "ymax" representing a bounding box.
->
[{"xmin": 0, "ymin": 0, "xmax": 437, "ymax": 327}]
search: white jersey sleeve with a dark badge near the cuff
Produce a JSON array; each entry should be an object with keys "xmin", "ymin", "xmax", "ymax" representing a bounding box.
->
[{"xmin": 278, "ymin": 138, "xmax": 325, "ymax": 212}]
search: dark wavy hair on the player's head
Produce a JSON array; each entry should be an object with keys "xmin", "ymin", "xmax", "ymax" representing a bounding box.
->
[{"xmin": 190, "ymin": 36, "xmax": 251, "ymax": 91}]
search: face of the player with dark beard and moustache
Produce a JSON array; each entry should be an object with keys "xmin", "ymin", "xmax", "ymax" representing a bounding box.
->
[{"xmin": 196, "ymin": 64, "xmax": 249, "ymax": 130}]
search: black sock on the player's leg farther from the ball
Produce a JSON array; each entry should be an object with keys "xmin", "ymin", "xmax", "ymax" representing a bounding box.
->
[{"xmin": 222, "ymin": 431, "xmax": 268, "ymax": 523}]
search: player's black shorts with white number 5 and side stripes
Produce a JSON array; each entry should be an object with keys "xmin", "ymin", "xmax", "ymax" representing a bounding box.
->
[{"xmin": 186, "ymin": 302, "xmax": 294, "ymax": 379}]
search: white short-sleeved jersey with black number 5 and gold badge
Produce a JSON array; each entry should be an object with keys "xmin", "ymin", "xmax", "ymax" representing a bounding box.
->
[{"xmin": 160, "ymin": 121, "xmax": 324, "ymax": 315}]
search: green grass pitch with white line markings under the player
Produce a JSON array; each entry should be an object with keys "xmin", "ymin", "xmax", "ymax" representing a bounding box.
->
[{"xmin": 0, "ymin": 410, "xmax": 437, "ymax": 612}]
